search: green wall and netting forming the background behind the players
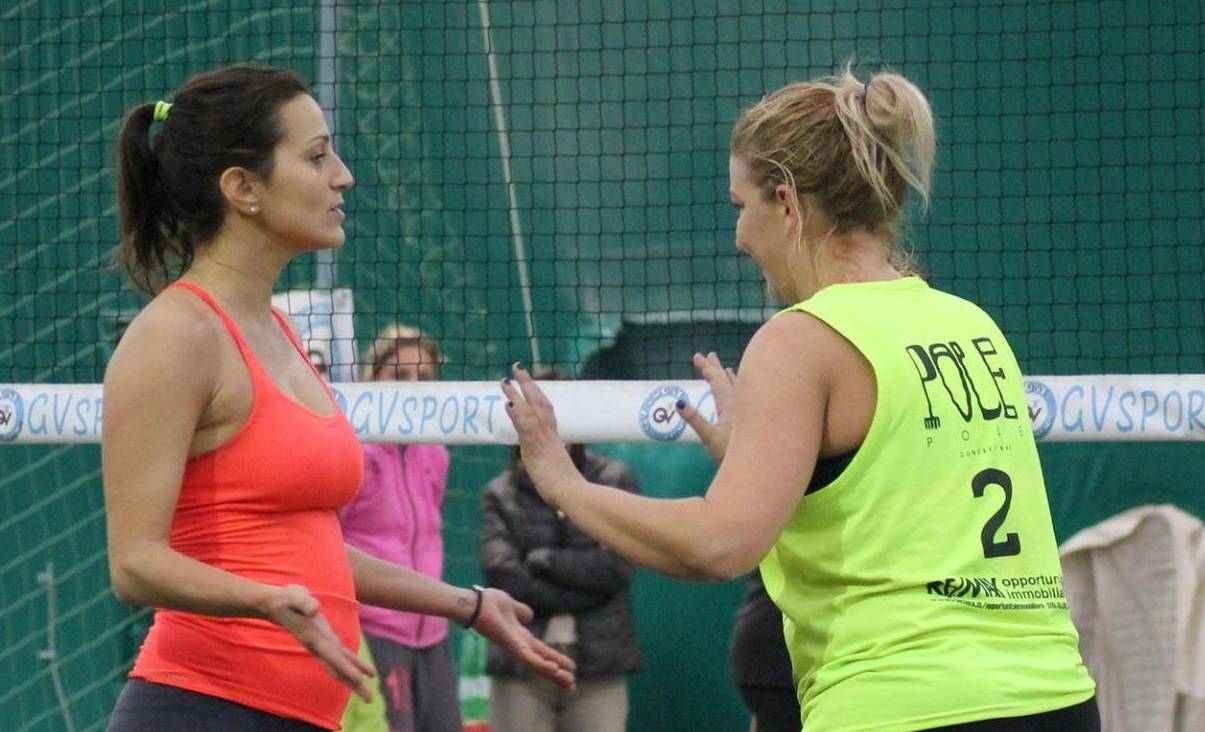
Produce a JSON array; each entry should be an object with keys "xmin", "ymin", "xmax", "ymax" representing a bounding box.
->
[{"xmin": 0, "ymin": 0, "xmax": 1205, "ymax": 732}]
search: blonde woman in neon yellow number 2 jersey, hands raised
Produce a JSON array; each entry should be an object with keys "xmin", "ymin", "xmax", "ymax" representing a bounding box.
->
[{"xmin": 502, "ymin": 69, "xmax": 1099, "ymax": 732}]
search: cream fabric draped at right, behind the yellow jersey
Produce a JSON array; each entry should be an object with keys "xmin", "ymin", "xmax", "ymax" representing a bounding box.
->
[{"xmin": 1060, "ymin": 505, "xmax": 1205, "ymax": 732}]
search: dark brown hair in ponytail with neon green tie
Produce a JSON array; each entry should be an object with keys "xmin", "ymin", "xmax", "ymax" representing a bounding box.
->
[{"xmin": 113, "ymin": 66, "xmax": 310, "ymax": 294}]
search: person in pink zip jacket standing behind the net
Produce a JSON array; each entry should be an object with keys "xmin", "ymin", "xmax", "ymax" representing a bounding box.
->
[{"xmin": 339, "ymin": 326, "xmax": 463, "ymax": 732}]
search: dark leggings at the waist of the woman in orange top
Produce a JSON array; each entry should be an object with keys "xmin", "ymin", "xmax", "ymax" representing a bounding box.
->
[{"xmin": 108, "ymin": 679, "xmax": 323, "ymax": 732}]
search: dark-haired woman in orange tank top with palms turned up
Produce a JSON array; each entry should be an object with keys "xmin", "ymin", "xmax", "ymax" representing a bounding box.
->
[{"xmin": 102, "ymin": 66, "xmax": 574, "ymax": 732}]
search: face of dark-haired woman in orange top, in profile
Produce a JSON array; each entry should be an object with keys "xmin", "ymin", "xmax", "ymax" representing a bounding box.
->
[{"xmin": 258, "ymin": 94, "xmax": 354, "ymax": 251}]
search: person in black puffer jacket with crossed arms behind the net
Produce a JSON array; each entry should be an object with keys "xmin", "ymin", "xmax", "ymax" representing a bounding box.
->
[{"xmin": 481, "ymin": 370, "xmax": 640, "ymax": 732}]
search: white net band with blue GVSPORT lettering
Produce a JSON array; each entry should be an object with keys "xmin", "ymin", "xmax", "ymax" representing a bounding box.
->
[{"xmin": 0, "ymin": 374, "xmax": 1205, "ymax": 445}]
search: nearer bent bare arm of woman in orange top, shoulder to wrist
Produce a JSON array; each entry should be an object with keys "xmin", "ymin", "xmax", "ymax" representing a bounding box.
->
[{"xmin": 101, "ymin": 301, "xmax": 276, "ymax": 617}]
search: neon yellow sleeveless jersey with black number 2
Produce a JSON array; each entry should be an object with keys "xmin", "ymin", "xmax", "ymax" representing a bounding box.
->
[{"xmin": 762, "ymin": 277, "xmax": 1095, "ymax": 732}]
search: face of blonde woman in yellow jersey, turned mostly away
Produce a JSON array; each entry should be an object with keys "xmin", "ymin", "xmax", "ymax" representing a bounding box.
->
[{"xmin": 728, "ymin": 156, "xmax": 795, "ymax": 303}]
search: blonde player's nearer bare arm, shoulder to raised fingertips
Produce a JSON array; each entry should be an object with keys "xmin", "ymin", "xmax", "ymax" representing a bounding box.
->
[{"xmin": 502, "ymin": 316, "xmax": 840, "ymax": 579}]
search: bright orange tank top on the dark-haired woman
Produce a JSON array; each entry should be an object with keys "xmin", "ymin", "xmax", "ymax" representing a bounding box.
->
[{"xmin": 130, "ymin": 282, "xmax": 364, "ymax": 730}]
